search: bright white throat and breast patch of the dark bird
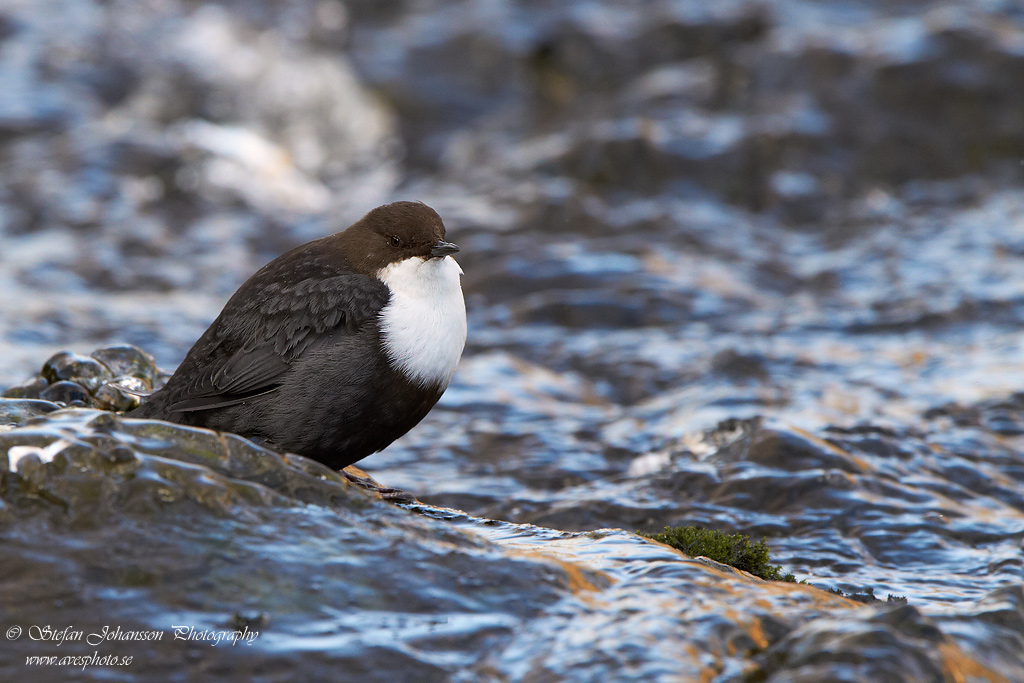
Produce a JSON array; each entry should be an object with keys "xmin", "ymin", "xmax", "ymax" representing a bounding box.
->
[{"xmin": 377, "ymin": 256, "xmax": 466, "ymax": 388}]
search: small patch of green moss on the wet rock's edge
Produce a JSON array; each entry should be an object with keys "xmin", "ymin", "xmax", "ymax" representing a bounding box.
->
[{"xmin": 641, "ymin": 526, "xmax": 797, "ymax": 583}]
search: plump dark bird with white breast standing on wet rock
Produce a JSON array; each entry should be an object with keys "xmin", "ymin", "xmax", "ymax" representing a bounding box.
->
[{"xmin": 129, "ymin": 202, "xmax": 466, "ymax": 469}]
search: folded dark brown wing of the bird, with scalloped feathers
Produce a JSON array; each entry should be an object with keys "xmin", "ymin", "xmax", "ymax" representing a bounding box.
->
[{"xmin": 166, "ymin": 272, "xmax": 389, "ymax": 413}]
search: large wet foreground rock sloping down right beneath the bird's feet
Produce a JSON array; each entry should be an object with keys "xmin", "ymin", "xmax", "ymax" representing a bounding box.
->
[{"xmin": 0, "ymin": 410, "xmax": 1007, "ymax": 683}]
